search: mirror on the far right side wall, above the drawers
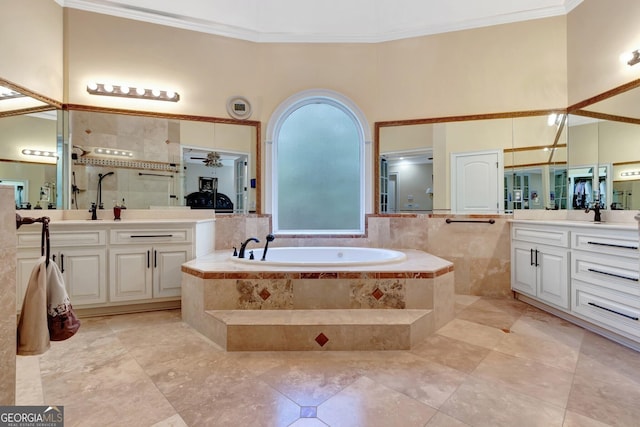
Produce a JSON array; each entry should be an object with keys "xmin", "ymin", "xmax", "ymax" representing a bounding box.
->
[{"xmin": 569, "ymin": 81, "xmax": 640, "ymax": 210}]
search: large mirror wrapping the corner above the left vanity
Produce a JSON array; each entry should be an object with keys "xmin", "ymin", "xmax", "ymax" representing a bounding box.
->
[{"xmin": 0, "ymin": 79, "xmax": 261, "ymax": 213}]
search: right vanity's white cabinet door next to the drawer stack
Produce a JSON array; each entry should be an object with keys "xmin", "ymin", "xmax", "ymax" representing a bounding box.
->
[{"xmin": 537, "ymin": 246, "xmax": 569, "ymax": 309}]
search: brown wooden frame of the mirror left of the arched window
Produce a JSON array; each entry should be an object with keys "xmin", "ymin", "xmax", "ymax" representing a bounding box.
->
[{"xmin": 62, "ymin": 104, "xmax": 262, "ymax": 215}]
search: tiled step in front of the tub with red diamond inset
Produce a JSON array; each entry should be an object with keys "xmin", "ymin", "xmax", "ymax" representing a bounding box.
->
[{"xmin": 206, "ymin": 309, "xmax": 433, "ymax": 351}]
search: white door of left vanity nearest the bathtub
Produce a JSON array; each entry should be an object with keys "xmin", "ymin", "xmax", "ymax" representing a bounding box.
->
[{"xmin": 153, "ymin": 245, "xmax": 191, "ymax": 298}]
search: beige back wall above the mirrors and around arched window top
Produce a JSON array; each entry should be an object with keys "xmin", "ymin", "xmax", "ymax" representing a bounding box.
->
[{"xmin": 65, "ymin": 9, "xmax": 567, "ymax": 125}]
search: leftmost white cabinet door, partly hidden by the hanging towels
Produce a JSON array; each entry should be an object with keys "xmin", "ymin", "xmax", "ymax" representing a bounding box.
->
[{"xmin": 56, "ymin": 248, "xmax": 107, "ymax": 307}]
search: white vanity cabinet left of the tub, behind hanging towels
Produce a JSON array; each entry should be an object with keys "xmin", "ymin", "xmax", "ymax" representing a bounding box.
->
[{"xmin": 17, "ymin": 219, "xmax": 215, "ymax": 313}]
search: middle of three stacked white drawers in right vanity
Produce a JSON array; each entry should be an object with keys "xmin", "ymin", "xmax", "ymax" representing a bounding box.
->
[{"xmin": 571, "ymin": 251, "xmax": 640, "ymax": 296}]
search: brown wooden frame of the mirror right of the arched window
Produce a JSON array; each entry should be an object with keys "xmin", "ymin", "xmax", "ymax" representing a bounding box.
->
[{"xmin": 373, "ymin": 108, "xmax": 567, "ymax": 215}]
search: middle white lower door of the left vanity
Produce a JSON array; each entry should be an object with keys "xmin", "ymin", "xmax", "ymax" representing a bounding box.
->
[{"xmin": 109, "ymin": 246, "xmax": 153, "ymax": 302}]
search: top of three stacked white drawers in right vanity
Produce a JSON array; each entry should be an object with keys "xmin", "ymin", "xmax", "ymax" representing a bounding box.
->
[{"xmin": 571, "ymin": 230, "xmax": 640, "ymax": 262}]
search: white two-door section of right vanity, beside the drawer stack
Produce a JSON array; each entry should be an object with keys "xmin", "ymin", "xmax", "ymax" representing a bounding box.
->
[{"xmin": 511, "ymin": 226, "xmax": 569, "ymax": 309}]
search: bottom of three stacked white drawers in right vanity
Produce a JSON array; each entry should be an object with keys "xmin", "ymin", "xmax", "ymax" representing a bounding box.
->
[{"xmin": 572, "ymin": 281, "xmax": 640, "ymax": 339}]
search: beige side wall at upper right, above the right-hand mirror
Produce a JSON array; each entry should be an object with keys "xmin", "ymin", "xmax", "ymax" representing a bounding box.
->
[{"xmin": 567, "ymin": 0, "xmax": 640, "ymax": 105}]
